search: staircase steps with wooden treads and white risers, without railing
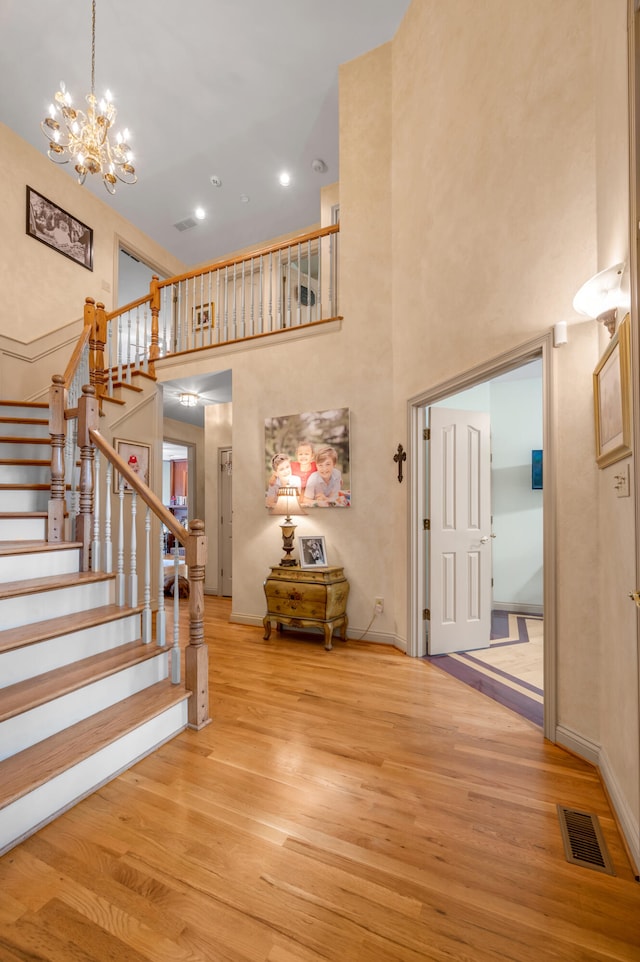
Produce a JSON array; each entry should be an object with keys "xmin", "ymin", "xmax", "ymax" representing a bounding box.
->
[{"xmin": 0, "ymin": 401, "xmax": 189, "ymax": 855}]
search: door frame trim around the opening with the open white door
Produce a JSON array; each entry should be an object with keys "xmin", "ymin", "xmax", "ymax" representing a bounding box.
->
[{"xmin": 407, "ymin": 331, "xmax": 557, "ymax": 741}]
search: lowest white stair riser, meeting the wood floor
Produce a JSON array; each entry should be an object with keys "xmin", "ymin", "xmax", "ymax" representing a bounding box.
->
[{"xmin": 0, "ymin": 700, "xmax": 187, "ymax": 855}]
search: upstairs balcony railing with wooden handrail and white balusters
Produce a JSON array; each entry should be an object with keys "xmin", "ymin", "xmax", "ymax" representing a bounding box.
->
[{"xmin": 100, "ymin": 225, "xmax": 340, "ymax": 393}]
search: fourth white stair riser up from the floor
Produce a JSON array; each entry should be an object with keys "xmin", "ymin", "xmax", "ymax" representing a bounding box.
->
[{"xmin": 0, "ymin": 581, "xmax": 113, "ymax": 628}]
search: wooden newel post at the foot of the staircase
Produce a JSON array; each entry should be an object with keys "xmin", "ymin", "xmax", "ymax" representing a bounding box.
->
[{"xmin": 185, "ymin": 519, "xmax": 211, "ymax": 729}]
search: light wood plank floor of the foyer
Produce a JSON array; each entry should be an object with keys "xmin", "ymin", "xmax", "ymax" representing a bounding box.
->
[{"xmin": 0, "ymin": 598, "xmax": 640, "ymax": 962}]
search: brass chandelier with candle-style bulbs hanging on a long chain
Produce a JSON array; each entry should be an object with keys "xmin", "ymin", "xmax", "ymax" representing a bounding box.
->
[{"xmin": 40, "ymin": 0, "xmax": 138, "ymax": 194}]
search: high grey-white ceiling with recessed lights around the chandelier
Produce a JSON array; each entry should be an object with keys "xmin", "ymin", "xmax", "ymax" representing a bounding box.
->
[{"xmin": 0, "ymin": 0, "xmax": 409, "ymax": 266}]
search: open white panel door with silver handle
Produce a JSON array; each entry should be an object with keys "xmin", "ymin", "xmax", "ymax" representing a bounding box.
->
[{"xmin": 428, "ymin": 407, "xmax": 492, "ymax": 655}]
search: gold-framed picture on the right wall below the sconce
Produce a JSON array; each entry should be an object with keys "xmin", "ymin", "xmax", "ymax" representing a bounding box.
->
[{"xmin": 593, "ymin": 314, "xmax": 631, "ymax": 468}]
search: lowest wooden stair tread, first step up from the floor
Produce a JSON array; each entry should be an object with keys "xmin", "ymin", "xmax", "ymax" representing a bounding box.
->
[{"xmin": 0, "ymin": 679, "xmax": 189, "ymax": 808}]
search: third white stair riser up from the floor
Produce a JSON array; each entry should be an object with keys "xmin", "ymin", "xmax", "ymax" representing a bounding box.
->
[{"xmin": 0, "ymin": 612, "xmax": 141, "ymax": 689}]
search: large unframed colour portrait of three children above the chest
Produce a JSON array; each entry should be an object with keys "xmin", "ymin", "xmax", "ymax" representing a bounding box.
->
[{"xmin": 264, "ymin": 408, "xmax": 351, "ymax": 508}]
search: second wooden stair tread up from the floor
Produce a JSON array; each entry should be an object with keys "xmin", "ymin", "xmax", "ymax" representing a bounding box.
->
[{"xmin": 0, "ymin": 639, "xmax": 169, "ymax": 722}]
